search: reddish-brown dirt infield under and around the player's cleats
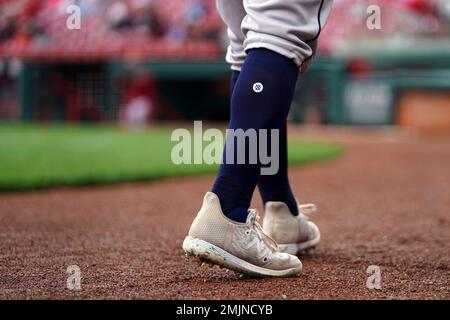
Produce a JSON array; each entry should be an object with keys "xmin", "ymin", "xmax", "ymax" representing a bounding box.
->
[{"xmin": 0, "ymin": 130, "xmax": 450, "ymax": 299}]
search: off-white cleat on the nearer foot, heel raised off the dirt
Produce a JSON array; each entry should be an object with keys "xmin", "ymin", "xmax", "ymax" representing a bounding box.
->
[{"xmin": 183, "ymin": 192, "xmax": 302, "ymax": 277}]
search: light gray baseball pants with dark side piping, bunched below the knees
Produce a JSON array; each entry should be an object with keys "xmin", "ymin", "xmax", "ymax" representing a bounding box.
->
[{"xmin": 217, "ymin": 0, "xmax": 333, "ymax": 72}]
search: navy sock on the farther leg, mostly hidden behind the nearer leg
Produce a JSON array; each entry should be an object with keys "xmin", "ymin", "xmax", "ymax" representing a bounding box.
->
[{"xmin": 229, "ymin": 70, "xmax": 298, "ymax": 216}]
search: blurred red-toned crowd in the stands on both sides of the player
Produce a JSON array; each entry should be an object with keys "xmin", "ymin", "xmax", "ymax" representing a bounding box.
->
[{"xmin": 0, "ymin": 0, "xmax": 450, "ymax": 52}]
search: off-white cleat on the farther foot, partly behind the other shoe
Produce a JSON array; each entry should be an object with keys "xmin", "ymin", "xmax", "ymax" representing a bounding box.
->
[{"xmin": 263, "ymin": 201, "xmax": 320, "ymax": 255}]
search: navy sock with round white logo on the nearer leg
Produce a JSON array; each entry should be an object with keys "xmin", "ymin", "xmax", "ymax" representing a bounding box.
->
[{"xmin": 212, "ymin": 48, "xmax": 298, "ymax": 222}]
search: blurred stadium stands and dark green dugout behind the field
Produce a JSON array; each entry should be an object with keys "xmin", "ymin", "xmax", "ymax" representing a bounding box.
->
[{"xmin": 0, "ymin": 0, "xmax": 450, "ymax": 130}]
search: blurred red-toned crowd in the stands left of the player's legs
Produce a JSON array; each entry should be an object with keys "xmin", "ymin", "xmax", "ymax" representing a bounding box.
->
[{"xmin": 0, "ymin": 0, "xmax": 222, "ymax": 43}]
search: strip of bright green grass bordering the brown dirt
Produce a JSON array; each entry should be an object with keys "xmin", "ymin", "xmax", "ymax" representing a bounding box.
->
[{"xmin": 0, "ymin": 124, "xmax": 342, "ymax": 191}]
